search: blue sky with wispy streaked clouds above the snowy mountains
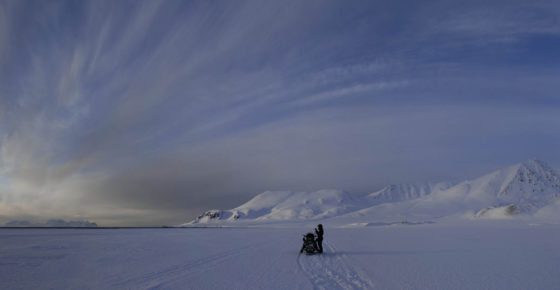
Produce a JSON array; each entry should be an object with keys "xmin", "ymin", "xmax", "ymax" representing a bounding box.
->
[{"xmin": 0, "ymin": 0, "xmax": 560, "ymax": 226}]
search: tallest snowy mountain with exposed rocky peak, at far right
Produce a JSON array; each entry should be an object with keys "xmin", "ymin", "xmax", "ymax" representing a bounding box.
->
[{"xmin": 342, "ymin": 159, "xmax": 560, "ymax": 221}]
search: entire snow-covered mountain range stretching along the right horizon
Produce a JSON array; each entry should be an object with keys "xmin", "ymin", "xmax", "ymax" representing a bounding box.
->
[{"xmin": 189, "ymin": 159, "xmax": 560, "ymax": 224}]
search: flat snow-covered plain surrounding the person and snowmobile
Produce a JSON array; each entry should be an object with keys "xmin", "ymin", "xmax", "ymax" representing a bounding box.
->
[{"xmin": 0, "ymin": 220, "xmax": 560, "ymax": 289}]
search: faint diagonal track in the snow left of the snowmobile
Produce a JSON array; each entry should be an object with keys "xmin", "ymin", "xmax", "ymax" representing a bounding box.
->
[{"xmin": 111, "ymin": 242, "xmax": 269, "ymax": 289}]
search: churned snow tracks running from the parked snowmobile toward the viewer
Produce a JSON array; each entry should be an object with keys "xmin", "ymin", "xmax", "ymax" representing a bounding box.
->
[{"xmin": 297, "ymin": 242, "xmax": 374, "ymax": 289}]
